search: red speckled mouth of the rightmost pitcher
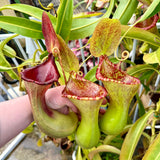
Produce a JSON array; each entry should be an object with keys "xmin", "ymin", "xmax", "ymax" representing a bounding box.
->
[{"xmin": 96, "ymin": 56, "xmax": 140, "ymax": 85}]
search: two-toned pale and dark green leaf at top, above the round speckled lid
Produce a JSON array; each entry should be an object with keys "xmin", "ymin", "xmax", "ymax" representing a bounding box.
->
[{"xmin": 113, "ymin": 0, "xmax": 138, "ymax": 24}]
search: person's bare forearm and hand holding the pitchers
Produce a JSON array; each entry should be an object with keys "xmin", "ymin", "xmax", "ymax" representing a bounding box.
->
[{"xmin": 0, "ymin": 86, "xmax": 77, "ymax": 147}]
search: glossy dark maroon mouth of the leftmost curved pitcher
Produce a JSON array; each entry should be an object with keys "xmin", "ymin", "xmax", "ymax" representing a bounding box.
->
[{"xmin": 21, "ymin": 53, "xmax": 60, "ymax": 85}]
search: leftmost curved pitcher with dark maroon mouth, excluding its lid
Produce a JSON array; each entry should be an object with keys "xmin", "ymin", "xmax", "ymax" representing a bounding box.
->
[{"xmin": 21, "ymin": 54, "xmax": 78, "ymax": 137}]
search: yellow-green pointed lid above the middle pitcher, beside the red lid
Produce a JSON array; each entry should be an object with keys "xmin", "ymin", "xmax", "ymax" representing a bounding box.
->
[{"xmin": 57, "ymin": 35, "xmax": 79, "ymax": 72}]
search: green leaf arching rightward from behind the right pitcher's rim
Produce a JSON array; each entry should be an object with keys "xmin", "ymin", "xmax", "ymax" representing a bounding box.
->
[{"xmin": 127, "ymin": 64, "xmax": 160, "ymax": 76}]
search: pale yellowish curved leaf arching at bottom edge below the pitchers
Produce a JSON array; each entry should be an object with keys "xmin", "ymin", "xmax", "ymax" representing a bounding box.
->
[{"xmin": 88, "ymin": 145, "xmax": 120, "ymax": 160}]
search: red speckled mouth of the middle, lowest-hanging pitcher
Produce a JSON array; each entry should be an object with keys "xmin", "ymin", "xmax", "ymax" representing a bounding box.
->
[{"xmin": 62, "ymin": 71, "xmax": 107, "ymax": 100}]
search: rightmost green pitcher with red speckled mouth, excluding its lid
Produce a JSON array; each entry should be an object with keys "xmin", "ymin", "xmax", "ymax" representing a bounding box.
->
[{"xmin": 96, "ymin": 56, "xmax": 140, "ymax": 135}]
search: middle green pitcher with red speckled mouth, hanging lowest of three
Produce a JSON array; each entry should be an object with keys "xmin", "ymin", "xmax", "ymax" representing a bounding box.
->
[{"xmin": 63, "ymin": 72, "xmax": 107, "ymax": 148}]
